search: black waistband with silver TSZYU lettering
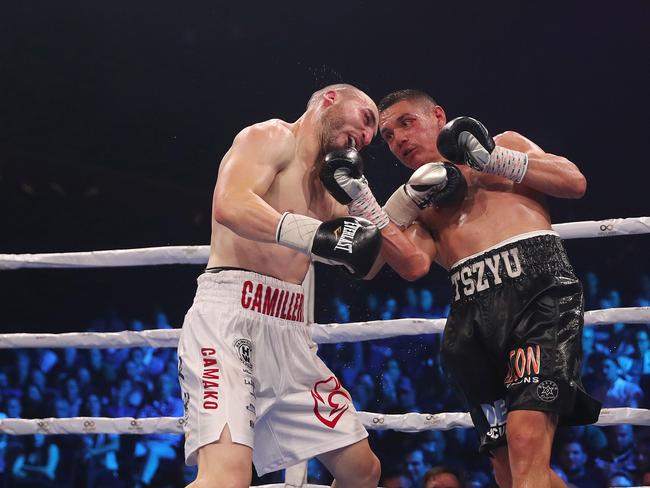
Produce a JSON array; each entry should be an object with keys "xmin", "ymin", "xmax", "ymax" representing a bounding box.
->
[{"xmin": 449, "ymin": 231, "xmax": 573, "ymax": 301}]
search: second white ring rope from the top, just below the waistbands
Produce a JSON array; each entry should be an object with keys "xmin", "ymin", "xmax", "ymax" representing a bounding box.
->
[{"xmin": 0, "ymin": 307, "xmax": 650, "ymax": 349}]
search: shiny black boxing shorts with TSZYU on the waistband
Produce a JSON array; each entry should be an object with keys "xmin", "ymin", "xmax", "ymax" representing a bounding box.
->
[{"xmin": 442, "ymin": 231, "xmax": 600, "ymax": 453}]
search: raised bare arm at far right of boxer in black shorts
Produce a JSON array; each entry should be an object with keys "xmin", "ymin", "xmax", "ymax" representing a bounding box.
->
[{"xmin": 494, "ymin": 131, "xmax": 587, "ymax": 198}]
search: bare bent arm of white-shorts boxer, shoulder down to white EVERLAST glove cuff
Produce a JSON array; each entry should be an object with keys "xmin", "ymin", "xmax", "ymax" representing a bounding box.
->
[{"xmin": 213, "ymin": 124, "xmax": 291, "ymax": 242}]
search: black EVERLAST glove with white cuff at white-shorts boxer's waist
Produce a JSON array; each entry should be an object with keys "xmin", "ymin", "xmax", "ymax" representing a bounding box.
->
[{"xmin": 275, "ymin": 212, "xmax": 381, "ymax": 278}]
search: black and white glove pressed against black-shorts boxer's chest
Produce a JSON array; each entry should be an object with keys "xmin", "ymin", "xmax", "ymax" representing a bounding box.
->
[{"xmin": 384, "ymin": 163, "xmax": 467, "ymax": 227}]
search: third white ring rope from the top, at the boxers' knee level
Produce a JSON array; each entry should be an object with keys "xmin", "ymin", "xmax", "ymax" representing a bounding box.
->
[{"xmin": 0, "ymin": 407, "xmax": 650, "ymax": 435}]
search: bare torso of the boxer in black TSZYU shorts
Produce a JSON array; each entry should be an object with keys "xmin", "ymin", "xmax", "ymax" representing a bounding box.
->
[{"xmin": 419, "ymin": 132, "xmax": 551, "ymax": 269}]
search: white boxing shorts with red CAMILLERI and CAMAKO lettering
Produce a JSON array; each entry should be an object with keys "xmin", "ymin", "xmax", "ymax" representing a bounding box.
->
[{"xmin": 178, "ymin": 269, "xmax": 368, "ymax": 476}]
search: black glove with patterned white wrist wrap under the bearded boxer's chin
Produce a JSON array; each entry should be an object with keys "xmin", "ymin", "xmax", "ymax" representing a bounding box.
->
[{"xmin": 319, "ymin": 148, "xmax": 388, "ymax": 229}]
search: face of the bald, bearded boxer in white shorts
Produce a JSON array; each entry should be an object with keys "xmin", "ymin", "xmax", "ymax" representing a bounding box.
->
[{"xmin": 322, "ymin": 90, "xmax": 379, "ymax": 154}]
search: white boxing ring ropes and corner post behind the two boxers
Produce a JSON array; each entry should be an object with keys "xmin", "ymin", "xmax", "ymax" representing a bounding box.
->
[{"xmin": 0, "ymin": 217, "xmax": 650, "ymax": 487}]
